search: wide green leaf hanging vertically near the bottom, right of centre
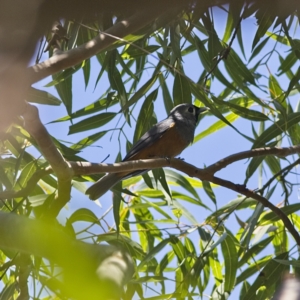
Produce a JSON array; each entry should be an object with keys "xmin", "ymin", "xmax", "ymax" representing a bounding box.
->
[{"xmin": 221, "ymin": 234, "xmax": 238, "ymax": 292}]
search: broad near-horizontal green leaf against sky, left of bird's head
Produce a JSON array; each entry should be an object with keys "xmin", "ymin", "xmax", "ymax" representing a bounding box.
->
[{"xmin": 69, "ymin": 112, "xmax": 117, "ymax": 134}]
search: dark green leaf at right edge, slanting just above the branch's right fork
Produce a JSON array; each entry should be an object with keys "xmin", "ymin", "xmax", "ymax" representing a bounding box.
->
[{"xmin": 252, "ymin": 112, "xmax": 300, "ymax": 149}]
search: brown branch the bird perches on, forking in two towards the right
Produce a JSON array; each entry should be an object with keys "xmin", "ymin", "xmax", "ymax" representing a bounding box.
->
[{"xmin": 67, "ymin": 146, "xmax": 300, "ymax": 246}]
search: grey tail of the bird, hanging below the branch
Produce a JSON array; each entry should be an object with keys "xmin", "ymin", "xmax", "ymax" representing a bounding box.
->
[{"xmin": 85, "ymin": 173, "xmax": 122, "ymax": 200}]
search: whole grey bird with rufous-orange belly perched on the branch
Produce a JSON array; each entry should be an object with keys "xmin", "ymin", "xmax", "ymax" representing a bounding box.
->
[{"xmin": 86, "ymin": 103, "xmax": 209, "ymax": 200}]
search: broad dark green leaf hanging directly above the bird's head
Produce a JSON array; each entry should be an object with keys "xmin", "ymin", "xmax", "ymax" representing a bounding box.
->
[{"xmin": 173, "ymin": 73, "xmax": 192, "ymax": 106}]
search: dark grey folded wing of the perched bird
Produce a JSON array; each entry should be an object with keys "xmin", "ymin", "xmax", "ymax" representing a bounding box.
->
[{"xmin": 123, "ymin": 118, "xmax": 175, "ymax": 161}]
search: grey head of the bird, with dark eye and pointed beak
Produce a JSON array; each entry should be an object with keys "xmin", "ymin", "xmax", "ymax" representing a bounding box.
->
[{"xmin": 169, "ymin": 103, "xmax": 208, "ymax": 123}]
